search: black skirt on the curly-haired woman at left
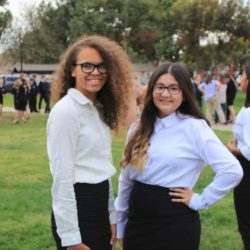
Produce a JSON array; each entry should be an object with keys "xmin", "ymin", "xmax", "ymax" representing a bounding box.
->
[{"xmin": 51, "ymin": 181, "xmax": 111, "ymax": 250}]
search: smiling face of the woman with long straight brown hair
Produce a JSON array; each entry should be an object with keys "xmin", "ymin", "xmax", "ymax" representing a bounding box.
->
[{"xmin": 153, "ymin": 73, "xmax": 183, "ymax": 118}]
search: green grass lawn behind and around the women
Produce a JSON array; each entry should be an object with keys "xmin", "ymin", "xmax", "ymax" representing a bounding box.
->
[{"xmin": 0, "ymin": 93, "xmax": 244, "ymax": 250}]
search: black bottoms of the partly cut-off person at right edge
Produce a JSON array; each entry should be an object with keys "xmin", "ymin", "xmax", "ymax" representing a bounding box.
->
[{"xmin": 234, "ymin": 156, "xmax": 250, "ymax": 250}]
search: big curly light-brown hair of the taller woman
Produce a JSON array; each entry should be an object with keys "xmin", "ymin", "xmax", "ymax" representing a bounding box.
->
[{"xmin": 52, "ymin": 35, "xmax": 132, "ymax": 129}]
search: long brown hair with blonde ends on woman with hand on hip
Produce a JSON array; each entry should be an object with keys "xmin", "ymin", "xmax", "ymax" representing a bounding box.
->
[{"xmin": 121, "ymin": 62, "xmax": 209, "ymax": 170}]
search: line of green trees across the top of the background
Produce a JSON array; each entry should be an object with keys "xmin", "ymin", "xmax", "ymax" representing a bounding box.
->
[{"xmin": 0, "ymin": 0, "xmax": 250, "ymax": 69}]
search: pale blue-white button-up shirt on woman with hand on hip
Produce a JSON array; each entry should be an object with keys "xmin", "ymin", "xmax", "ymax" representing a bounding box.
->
[{"xmin": 115, "ymin": 113, "xmax": 243, "ymax": 238}]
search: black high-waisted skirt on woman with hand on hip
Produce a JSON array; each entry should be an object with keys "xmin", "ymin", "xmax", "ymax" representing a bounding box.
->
[{"xmin": 123, "ymin": 182, "xmax": 201, "ymax": 250}]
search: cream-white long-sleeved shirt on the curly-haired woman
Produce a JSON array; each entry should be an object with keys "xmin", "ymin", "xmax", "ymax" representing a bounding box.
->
[{"xmin": 47, "ymin": 88, "xmax": 116, "ymax": 246}]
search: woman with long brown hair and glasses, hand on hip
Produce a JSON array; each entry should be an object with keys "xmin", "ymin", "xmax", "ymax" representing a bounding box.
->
[{"xmin": 115, "ymin": 63, "xmax": 242, "ymax": 250}]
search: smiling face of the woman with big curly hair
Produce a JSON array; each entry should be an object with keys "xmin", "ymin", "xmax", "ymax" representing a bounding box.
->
[{"xmin": 71, "ymin": 47, "xmax": 107, "ymax": 102}]
